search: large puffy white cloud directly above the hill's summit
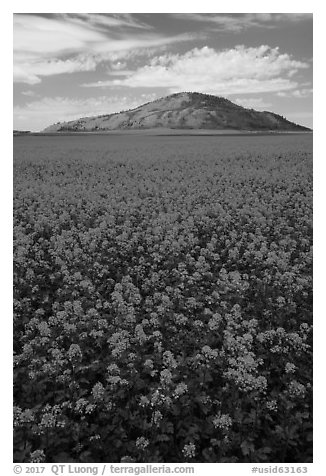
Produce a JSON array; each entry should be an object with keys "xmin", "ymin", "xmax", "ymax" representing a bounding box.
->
[{"xmin": 83, "ymin": 45, "xmax": 309, "ymax": 95}]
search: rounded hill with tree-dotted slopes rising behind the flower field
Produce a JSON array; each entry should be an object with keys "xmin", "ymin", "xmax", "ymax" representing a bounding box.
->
[{"xmin": 42, "ymin": 92, "xmax": 311, "ymax": 133}]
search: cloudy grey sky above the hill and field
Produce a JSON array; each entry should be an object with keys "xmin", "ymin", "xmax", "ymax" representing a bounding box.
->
[{"xmin": 13, "ymin": 13, "xmax": 313, "ymax": 131}]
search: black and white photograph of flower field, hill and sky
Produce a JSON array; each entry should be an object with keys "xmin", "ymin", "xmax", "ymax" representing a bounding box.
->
[{"xmin": 10, "ymin": 3, "xmax": 314, "ymax": 475}]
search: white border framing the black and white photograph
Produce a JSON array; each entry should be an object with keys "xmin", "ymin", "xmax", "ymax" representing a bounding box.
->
[{"xmin": 5, "ymin": 0, "xmax": 320, "ymax": 476}]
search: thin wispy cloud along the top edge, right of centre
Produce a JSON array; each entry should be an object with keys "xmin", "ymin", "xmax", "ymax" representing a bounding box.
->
[{"xmin": 171, "ymin": 13, "xmax": 312, "ymax": 32}]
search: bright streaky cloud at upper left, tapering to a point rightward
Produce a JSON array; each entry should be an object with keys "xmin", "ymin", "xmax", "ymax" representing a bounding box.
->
[{"xmin": 14, "ymin": 14, "xmax": 193, "ymax": 85}]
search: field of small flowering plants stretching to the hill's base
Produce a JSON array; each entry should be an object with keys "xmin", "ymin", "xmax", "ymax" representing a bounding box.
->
[{"xmin": 14, "ymin": 135, "xmax": 312, "ymax": 463}]
